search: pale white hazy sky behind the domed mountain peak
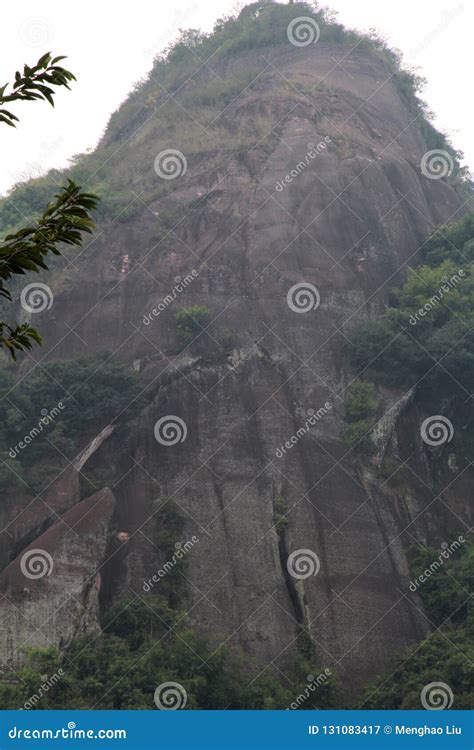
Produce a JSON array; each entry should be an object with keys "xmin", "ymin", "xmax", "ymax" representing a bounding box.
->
[{"xmin": 0, "ymin": 0, "xmax": 474, "ymax": 194}]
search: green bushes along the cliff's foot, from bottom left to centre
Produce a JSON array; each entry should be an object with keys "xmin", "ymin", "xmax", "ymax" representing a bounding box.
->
[{"xmin": 0, "ymin": 596, "xmax": 335, "ymax": 709}]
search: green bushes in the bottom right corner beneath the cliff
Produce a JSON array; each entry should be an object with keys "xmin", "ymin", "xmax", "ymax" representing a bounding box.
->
[{"xmin": 358, "ymin": 542, "xmax": 474, "ymax": 709}]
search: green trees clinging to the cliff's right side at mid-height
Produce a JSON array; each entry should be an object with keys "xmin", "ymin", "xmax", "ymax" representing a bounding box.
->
[{"xmin": 350, "ymin": 214, "xmax": 474, "ymax": 392}]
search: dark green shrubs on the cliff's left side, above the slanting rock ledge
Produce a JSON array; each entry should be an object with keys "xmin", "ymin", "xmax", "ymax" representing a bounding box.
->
[{"xmin": 0, "ymin": 354, "xmax": 141, "ymax": 492}]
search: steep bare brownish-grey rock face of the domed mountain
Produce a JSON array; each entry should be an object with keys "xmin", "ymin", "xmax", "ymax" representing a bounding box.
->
[{"xmin": 1, "ymin": 23, "xmax": 468, "ymax": 687}]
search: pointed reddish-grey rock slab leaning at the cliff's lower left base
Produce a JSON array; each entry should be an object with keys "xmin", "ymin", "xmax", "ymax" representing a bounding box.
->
[{"xmin": 0, "ymin": 489, "xmax": 114, "ymax": 665}]
